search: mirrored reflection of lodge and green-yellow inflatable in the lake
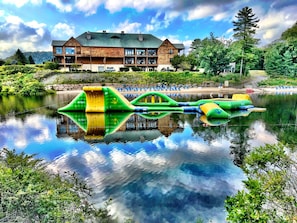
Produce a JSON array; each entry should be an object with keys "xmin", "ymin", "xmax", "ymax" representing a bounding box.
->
[{"xmin": 57, "ymin": 112, "xmax": 179, "ymax": 143}]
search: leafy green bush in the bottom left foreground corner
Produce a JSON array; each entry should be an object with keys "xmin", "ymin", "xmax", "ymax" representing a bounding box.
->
[{"xmin": 0, "ymin": 149, "xmax": 109, "ymax": 222}]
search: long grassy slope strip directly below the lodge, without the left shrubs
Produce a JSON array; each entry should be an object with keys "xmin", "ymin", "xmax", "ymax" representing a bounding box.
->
[{"xmin": 43, "ymin": 71, "xmax": 239, "ymax": 86}]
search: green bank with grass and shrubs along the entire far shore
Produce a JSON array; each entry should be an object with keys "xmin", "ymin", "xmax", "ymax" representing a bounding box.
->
[{"xmin": 0, "ymin": 65, "xmax": 297, "ymax": 96}]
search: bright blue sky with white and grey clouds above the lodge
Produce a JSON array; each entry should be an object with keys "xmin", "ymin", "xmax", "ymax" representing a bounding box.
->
[{"xmin": 0, "ymin": 0, "xmax": 297, "ymax": 59}]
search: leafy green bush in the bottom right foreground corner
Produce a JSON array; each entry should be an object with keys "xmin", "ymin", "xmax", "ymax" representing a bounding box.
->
[{"xmin": 225, "ymin": 144, "xmax": 297, "ymax": 222}]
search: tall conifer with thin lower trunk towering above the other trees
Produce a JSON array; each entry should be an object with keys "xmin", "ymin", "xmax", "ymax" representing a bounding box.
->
[{"xmin": 233, "ymin": 6, "xmax": 260, "ymax": 75}]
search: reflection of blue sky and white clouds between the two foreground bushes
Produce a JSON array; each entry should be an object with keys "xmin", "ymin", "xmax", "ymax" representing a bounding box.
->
[{"xmin": 52, "ymin": 123, "xmax": 244, "ymax": 222}]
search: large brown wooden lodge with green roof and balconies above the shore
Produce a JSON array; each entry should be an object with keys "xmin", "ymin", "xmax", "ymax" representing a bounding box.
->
[{"xmin": 52, "ymin": 31, "xmax": 184, "ymax": 72}]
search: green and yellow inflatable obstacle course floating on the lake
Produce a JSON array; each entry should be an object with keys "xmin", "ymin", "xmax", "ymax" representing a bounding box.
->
[{"xmin": 59, "ymin": 86, "xmax": 262, "ymax": 119}]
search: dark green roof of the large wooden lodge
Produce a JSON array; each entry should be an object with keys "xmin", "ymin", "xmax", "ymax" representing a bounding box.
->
[{"xmin": 52, "ymin": 31, "xmax": 184, "ymax": 49}]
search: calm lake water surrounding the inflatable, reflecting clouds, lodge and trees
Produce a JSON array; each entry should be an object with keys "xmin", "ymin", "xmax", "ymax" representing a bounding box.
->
[{"xmin": 0, "ymin": 91, "xmax": 297, "ymax": 223}]
